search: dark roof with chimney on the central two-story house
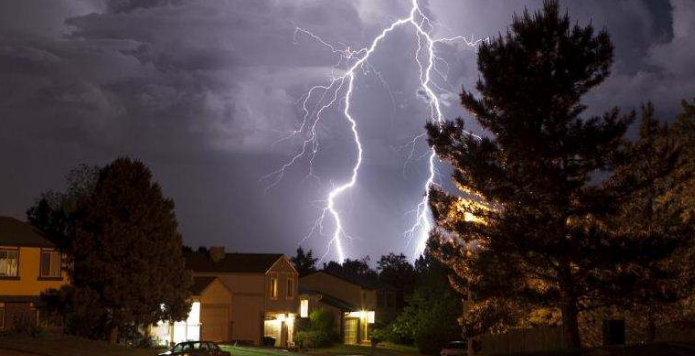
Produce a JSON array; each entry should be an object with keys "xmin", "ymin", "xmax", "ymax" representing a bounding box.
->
[{"xmin": 185, "ymin": 252, "xmax": 283, "ymax": 273}]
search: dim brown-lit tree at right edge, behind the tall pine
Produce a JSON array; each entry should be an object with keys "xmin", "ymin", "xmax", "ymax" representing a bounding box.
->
[{"xmin": 606, "ymin": 104, "xmax": 694, "ymax": 342}]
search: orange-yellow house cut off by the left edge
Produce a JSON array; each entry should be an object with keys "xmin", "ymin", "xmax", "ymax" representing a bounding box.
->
[{"xmin": 0, "ymin": 216, "xmax": 68, "ymax": 330}]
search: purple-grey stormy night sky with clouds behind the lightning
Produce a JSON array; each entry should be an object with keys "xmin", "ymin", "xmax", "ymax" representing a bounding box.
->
[{"xmin": 0, "ymin": 0, "xmax": 695, "ymax": 258}]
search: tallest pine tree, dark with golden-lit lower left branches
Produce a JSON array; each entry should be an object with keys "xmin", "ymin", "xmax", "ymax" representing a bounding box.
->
[{"xmin": 427, "ymin": 1, "xmax": 692, "ymax": 347}]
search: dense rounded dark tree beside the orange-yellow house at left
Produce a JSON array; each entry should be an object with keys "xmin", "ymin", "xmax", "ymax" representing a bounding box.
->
[{"xmin": 70, "ymin": 158, "xmax": 192, "ymax": 342}]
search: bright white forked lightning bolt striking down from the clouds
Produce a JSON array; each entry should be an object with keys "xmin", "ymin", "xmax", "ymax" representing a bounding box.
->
[{"xmin": 261, "ymin": 0, "xmax": 488, "ymax": 263}]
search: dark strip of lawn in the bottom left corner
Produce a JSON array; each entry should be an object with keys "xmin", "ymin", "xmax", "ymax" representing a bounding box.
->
[{"xmin": 0, "ymin": 334, "xmax": 163, "ymax": 356}]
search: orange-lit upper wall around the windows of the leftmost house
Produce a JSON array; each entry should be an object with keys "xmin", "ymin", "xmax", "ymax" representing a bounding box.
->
[{"xmin": 0, "ymin": 246, "xmax": 68, "ymax": 297}]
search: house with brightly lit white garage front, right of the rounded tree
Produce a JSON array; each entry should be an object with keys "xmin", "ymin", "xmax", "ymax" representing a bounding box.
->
[{"xmin": 153, "ymin": 247, "xmax": 299, "ymax": 346}]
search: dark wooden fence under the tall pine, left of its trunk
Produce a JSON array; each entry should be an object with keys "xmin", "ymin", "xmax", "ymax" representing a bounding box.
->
[{"xmin": 480, "ymin": 327, "xmax": 565, "ymax": 355}]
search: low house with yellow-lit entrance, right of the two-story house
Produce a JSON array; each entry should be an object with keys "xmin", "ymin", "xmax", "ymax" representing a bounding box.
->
[{"xmin": 299, "ymin": 271, "xmax": 381, "ymax": 344}]
